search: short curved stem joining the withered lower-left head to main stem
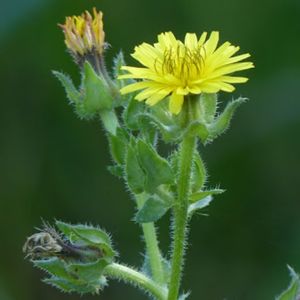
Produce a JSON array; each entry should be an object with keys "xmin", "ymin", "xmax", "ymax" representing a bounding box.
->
[{"xmin": 104, "ymin": 263, "xmax": 167, "ymax": 300}]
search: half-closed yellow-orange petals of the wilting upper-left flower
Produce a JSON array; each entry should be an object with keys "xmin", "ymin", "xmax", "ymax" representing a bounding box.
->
[{"xmin": 60, "ymin": 8, "xmax": 105, "ymax": 56}]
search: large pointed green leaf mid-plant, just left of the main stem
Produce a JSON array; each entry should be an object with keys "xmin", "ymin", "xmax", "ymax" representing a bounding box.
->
[{"xmin": 137, "ymin": 140, "xmax": 174, "ymax": 193}]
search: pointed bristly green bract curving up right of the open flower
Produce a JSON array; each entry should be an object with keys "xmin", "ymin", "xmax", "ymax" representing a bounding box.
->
[{"xmin": 209, "ymin": 98, "xmax": 247, "ymax": 140}]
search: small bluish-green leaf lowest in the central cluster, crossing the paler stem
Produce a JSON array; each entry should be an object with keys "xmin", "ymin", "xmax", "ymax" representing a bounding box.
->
[{"xmin": 135, "ymin": 195, "xmax": 172, "ymax": 223}]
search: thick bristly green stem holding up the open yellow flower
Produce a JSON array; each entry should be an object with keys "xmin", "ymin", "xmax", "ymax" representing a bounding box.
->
[{"xmin": 168, "ymin": 136, "xmax": 196, "ymax": 300}]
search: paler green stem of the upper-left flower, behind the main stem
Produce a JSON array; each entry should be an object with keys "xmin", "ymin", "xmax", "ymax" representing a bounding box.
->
[{"xmin": 136, "ymin": 194, "xmax": 164, "ymax": 283}]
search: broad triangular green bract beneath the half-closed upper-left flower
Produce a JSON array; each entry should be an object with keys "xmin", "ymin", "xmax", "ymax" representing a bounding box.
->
[{"xmin": 83, "ymin": 62, "xmax": 113, "ymax": 115}]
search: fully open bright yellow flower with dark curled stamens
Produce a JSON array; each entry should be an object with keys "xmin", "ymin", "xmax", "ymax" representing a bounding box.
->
[{"xmin": 119, "ymin": 31, "xmax": 254, "ymax": 114}]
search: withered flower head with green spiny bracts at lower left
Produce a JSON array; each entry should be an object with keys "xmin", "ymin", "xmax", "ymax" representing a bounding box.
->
[{"xmin": 23, "ymin": 221, "xmax": 116, "ymax": 295}]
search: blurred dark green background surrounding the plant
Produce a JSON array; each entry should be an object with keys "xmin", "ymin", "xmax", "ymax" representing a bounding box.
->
[{"xmin": 0, "ymin": 0, "xmax": 300, "ymax": 300}]
